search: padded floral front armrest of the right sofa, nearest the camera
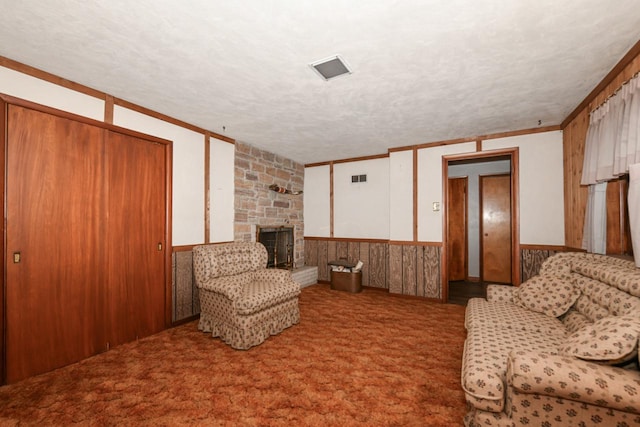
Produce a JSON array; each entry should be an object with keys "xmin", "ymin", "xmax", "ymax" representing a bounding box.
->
[{"xmin": 507, "ymin": 351, "xmax": 640, "ymax": 414}]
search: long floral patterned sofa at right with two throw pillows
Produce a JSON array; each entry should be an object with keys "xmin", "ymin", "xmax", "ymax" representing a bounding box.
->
[{"xmin": 461, "ymin": 252, "xmax": 640, "ymax": 427}]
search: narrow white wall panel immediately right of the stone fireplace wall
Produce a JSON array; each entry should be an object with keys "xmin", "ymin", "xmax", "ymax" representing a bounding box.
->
[{"xmin": 302, "ymin": 165, "xmax": 331, "ymax": 237}]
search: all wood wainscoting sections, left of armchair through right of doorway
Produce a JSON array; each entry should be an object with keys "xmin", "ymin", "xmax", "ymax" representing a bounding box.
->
[{"xmin": 171, "ymin": 241, "xmax": 565, "ymax": 310}]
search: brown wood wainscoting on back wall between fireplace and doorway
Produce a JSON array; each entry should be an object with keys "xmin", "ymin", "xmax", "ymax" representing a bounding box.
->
[{"xmin": 304, "ymin": 237, "xmax": 442, "ymax": 300}]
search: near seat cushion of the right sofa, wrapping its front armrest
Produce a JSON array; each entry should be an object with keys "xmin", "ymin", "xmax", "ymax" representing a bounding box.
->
[{"xmin": 462, "ymin": 325, "xmax": 564, "ymax": 412}]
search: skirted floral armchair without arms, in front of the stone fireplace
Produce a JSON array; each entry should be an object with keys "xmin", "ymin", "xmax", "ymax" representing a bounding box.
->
[{"xmin": 193, "ymin": 242, "xmax": 300, "ymax": 350}]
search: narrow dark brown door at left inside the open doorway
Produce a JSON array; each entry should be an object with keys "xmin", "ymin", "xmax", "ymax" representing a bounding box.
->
[{"xmin": 446, "ymin": 177, "xmax": 468, "ymax": 281}]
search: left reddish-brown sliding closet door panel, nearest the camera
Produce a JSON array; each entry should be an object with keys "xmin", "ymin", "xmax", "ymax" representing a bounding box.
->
[{"xmin": 5, "ymin": 105, "xmax": 106, "ymax": 382}]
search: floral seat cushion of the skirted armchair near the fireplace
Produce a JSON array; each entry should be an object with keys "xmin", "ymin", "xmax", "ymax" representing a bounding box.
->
[{"xmin": 235, "ymin": 280, "xmax": 300, "ymax": 315}]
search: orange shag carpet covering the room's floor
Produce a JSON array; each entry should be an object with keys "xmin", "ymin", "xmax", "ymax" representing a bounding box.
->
[{"xmin": 0, "ymin": 284, "xmax": 465, "ymax": 426}]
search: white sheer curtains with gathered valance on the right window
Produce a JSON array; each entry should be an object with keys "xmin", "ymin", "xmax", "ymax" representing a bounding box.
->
[{"xmin": 581, "ymin": 75, "xmax": 640, "ymax": 259}]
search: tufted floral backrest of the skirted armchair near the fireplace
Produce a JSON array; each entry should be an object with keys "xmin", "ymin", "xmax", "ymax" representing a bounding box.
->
[{"xmin": 193, "ymin": 242, "xmax": 268, "ymax": 283}]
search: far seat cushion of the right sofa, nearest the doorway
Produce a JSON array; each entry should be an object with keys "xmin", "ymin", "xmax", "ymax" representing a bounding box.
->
[{"xmin": 465, "ymin": 298, "xmax": 566, "ymax": 336}]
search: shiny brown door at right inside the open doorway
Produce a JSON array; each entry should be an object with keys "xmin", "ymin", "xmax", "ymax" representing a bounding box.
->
[{"xmin": 480, "ymin": 175, "xmax": 512, "ymax": 283}]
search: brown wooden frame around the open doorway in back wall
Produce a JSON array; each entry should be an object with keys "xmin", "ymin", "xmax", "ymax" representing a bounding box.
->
[{"xmin": 440, "ymin": 147, "xmax": 521, "ymax": 302}]
